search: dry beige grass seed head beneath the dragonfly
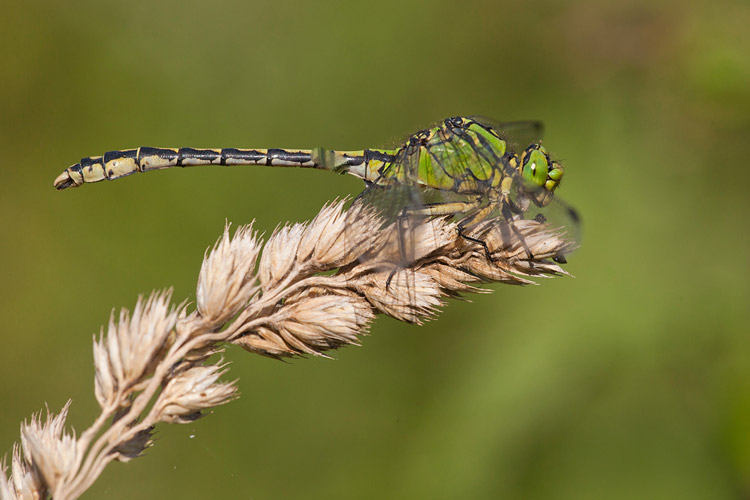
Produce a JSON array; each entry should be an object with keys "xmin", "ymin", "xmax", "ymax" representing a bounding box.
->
[{"xmin": 0, "ymin": 197, "xmax": 574, "ymax": 500}]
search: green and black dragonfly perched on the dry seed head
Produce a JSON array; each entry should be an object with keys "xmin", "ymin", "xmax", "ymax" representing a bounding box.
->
[{"xmin": 54, "ymin": 116, "xmax": 580, "ymax": 262}]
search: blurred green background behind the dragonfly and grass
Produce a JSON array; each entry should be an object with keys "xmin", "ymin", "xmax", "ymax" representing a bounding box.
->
[{"xmin": 0, "ymin": 0, "xmax": 750, "ymax": 499}]
